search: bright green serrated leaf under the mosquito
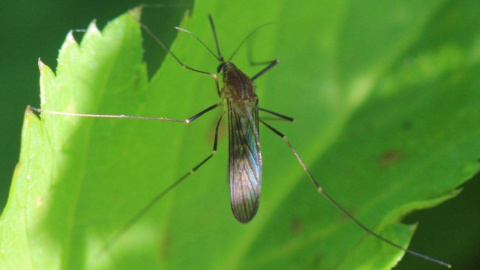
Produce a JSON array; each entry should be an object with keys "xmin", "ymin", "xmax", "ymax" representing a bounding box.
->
[{"xmin": 0, "ymin": 0, "xmax": 480, "ymax": 270}]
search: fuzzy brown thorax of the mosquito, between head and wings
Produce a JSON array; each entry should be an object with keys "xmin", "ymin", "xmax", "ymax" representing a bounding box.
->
[{"xmin": 218, "ymin": 62, "xmax": 257, "ymax": 102}]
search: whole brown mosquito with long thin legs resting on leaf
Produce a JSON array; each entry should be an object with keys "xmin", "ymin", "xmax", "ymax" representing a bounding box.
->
[{"xmin": 28, "ymin": 10, "xmax": 451, "ymax": 268}]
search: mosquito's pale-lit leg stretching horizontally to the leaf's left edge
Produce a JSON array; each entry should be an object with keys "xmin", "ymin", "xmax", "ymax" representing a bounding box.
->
[{"xmin": 28, "ymin": 103, "xmax": 220, "ymax": 124}]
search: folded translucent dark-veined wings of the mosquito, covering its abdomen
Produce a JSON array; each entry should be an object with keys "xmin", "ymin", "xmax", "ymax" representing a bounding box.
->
[{"xmin": 228, "ymin": 100, "xmax": 262, "ymax": 223}]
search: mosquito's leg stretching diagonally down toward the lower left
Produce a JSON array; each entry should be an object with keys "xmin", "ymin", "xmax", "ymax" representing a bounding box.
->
[{"xmin": 98, "ymin": 114, "xmax": 223, "ymax": 255}]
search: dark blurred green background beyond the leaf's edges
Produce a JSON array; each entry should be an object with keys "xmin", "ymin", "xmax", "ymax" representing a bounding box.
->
[{"xmin": 0, "ymin": 0, "xmax": 480, "ymax": 269}]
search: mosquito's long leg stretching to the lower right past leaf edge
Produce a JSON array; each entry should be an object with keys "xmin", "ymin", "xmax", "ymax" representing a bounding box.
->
[{"xmin": 260, "ymin": 120, "xmax": 451, "ymax": 268}]
